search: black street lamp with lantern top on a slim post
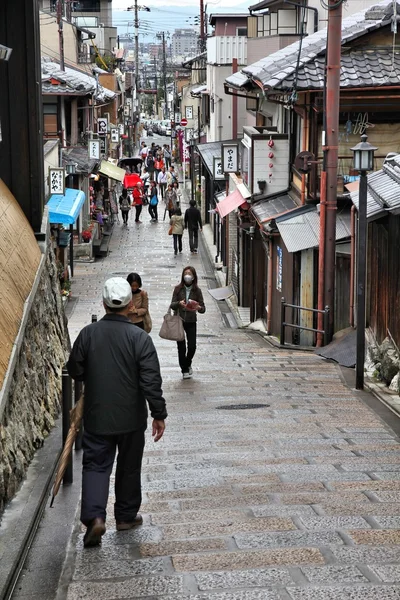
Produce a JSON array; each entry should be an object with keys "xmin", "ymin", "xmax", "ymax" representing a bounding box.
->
[{"xmin": 351, "ymin": 134, "xmax": 378, "ymax": 390}]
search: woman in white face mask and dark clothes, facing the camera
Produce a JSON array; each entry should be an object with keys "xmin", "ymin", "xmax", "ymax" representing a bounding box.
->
[{"xmin": 171, "ymin": 267, "xmax": 206, "ymax": 379}]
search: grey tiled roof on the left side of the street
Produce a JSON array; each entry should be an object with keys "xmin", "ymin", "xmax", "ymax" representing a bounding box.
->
[{"xmin": 42, "ymin": 57, "xmax": 116, "ymax": 103}]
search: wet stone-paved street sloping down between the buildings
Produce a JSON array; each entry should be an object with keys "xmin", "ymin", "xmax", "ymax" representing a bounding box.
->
[{"xmin": 32, "ymin": 195, "xmax": 400, "ymax": 600}]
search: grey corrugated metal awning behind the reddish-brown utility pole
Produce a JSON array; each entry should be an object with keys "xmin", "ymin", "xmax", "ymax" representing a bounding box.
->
[{"xmin": 276, "ymin": 206, "xmax": 351, "ymax": 252}]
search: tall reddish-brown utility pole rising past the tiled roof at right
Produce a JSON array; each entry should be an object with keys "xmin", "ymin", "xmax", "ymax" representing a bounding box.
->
[{"xmin": 318, "ymin": 0, "xmax": 342, "ymax": 345}]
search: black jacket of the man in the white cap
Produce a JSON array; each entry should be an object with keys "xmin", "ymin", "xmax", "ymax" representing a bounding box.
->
[{"xmin": 67, "ymin": 314, "xmax": 167, "ymax": 435}]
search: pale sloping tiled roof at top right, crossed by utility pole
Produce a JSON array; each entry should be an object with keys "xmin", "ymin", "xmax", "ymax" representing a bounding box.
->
[{"xmin": 226, "ymin": 0, "xmax": 399, "ymax": 90}]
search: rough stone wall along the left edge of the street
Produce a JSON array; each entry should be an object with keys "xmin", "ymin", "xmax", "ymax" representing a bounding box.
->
[{"xmin": 0, "ymin": 244, "xmax": 69, "ymax": 513}]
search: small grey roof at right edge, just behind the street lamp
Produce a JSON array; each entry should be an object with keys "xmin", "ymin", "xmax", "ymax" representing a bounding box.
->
[{"xmin": 350, "ymin": 154, "xmax": 400, "ymax": 219}]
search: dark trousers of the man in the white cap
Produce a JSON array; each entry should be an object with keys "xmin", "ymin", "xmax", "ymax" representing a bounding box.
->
[{"xmin": 81, "ymin": 428, "xmax": 145, "ymax": 525}]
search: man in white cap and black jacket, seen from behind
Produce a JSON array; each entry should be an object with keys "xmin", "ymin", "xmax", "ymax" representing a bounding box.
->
[{"xmin": 67, "ymin": 277, "xmax": 167, "ymax": 547}]
